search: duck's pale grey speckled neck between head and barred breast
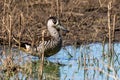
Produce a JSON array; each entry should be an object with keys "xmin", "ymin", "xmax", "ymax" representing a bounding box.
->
[{"xmin": 48, "ymin": 26, "xmax": 61, "ymax": 40}]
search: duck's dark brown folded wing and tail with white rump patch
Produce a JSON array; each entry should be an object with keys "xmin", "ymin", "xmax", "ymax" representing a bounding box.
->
[{"xmin": 13, "ymin": 33, "xmax": 52, "ymax": 52}]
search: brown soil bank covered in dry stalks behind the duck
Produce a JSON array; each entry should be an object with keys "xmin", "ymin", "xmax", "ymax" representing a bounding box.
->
[{"xmin": 0, "ymin": 0, "xmax": 120, "ymax": 45}]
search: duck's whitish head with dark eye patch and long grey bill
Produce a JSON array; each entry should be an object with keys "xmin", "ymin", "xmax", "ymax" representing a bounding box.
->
[{"xmin": 47, "ymin": 16, "xmax": 69, "ymax": 32}]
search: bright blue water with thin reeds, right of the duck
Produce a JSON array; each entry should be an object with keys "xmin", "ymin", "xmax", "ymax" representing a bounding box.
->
[{"xmin": 48, "ymin": 43, "xmax": 120, "ymax": 80}]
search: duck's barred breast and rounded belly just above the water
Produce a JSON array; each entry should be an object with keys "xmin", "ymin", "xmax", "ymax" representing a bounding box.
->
[{"xmin": 37, "ymin": 39, "xmax": 62, "ymax": 57}]
